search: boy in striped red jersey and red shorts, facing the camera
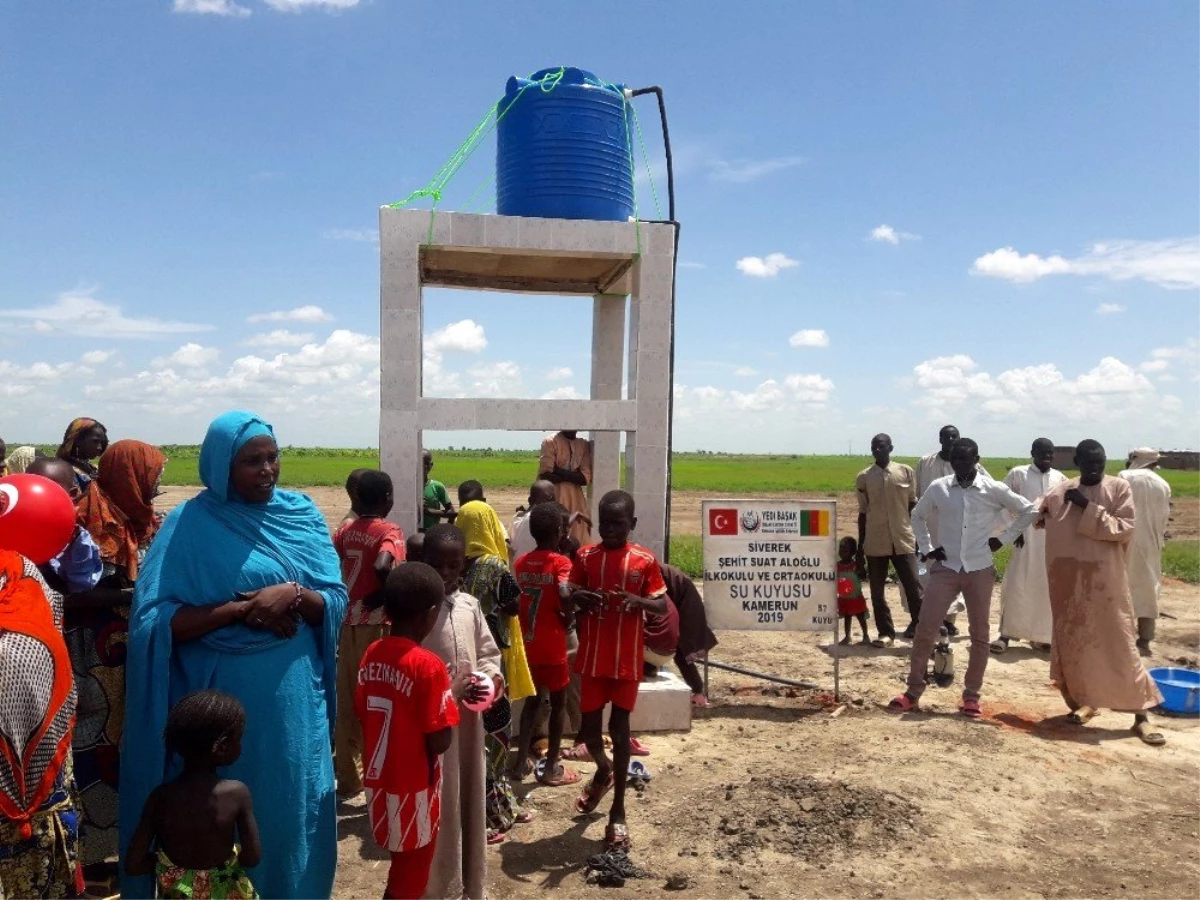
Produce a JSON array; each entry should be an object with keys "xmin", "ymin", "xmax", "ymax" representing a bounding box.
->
[{"xmin": 571, "ymin": 491, "xmax": 667, "ymax": 850}]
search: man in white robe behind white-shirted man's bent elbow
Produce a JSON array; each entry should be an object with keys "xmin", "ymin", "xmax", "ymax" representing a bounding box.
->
[{"xmin": 991, "ymin": 438, "xmax": 1067, "ymax": 653}]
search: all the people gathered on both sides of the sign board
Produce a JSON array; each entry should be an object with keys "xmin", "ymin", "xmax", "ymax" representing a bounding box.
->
[{"xmin": 0, "ymin": 412, "xmax": 1170, "ymax": 900}]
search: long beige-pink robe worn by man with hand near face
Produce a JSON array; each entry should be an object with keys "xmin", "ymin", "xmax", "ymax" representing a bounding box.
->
[{"xmin": 1040, "ymin": 475, "xmax": 1162, "ymax": 713}]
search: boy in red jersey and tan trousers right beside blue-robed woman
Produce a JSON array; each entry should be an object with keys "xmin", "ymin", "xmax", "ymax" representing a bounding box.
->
[{"xmin": 334, "ymin": 469, "xmax": 404, "ymax": 798}]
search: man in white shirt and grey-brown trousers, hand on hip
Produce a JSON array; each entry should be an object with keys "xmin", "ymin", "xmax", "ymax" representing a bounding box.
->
[{"xmin": 888, "ymin": 438, "xmax": 1038, "ymax": 719}]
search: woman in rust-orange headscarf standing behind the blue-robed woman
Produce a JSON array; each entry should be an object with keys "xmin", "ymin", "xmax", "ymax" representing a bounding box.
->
[{"xmin": 66, "ymin": 440, "xmax": 167, "ymax": 896}]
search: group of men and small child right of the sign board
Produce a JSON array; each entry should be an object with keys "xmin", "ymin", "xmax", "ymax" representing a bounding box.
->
[{"xmin": 854, "ymin": 425, "xmax": 1170, "ymax": 746}]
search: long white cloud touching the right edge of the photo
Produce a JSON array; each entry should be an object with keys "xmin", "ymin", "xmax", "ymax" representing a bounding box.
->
[{"xmin": 971, "ymin": 236, "xmax": 1200, "ymax": 290}]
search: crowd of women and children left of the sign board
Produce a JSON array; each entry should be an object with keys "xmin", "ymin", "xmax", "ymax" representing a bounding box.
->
[{"xmin": 0, "ymin": 412, "xmax": 716, "ymax": 900}]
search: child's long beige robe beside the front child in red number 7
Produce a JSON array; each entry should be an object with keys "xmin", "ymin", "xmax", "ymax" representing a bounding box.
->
[{"xmin": 421, "ymin": 590, "xmax": 500, "ymax": 900}]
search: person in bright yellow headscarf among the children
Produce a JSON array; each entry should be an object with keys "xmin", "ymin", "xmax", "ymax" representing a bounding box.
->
[{"xmin": 455, "ymin": 481, "xmax": 534, "ymax": 844}]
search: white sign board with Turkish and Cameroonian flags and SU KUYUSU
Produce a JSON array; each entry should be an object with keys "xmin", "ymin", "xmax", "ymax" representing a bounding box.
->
[{"xmin": 701, "ymin": 499, "xmax": 838, "ymax": 631}]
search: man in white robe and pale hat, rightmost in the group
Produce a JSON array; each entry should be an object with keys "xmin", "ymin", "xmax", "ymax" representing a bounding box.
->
[{"xmin": 1117, "ymin": 448, "xmax": 1171, "ymax": 656}]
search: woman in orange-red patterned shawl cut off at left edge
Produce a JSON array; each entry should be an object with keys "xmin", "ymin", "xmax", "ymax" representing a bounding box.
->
[{"xmin": 0, "ymin": 550, "xmax": 83, "ymax": 900}]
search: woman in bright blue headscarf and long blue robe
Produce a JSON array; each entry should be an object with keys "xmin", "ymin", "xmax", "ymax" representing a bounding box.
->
[{"xmin": 120, "ymin": 412, "xmax": 347, "ymax": 900}]
